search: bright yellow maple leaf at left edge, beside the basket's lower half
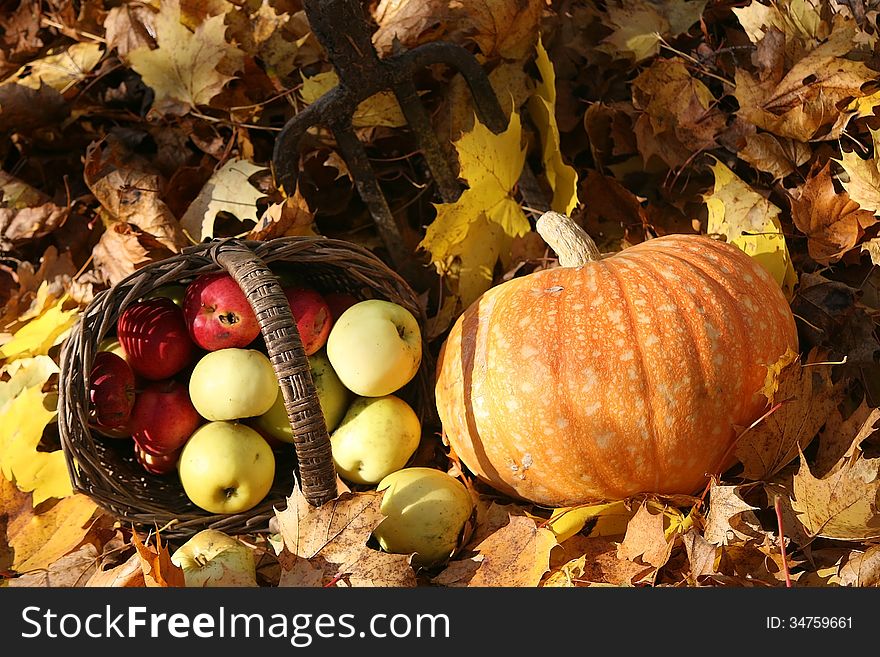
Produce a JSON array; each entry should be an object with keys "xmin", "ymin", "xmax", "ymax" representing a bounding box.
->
[{"xmin": 0, "ymin": 385, "xmax": 73, "ymax": 505}]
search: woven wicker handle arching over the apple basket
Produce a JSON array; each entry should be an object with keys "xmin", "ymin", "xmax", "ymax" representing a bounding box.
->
[{"xmin": 211, "ymin": 240, "xmax": 337, "ymax": 506}]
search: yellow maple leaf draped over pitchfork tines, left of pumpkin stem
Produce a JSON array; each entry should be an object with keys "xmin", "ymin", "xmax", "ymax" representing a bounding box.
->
[{"xmin": 419, "ymin": 112, "xmax": 531, "ymax": 316}]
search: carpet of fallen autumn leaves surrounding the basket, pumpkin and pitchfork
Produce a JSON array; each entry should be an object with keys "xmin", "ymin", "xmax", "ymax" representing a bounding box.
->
[{"xmin": 0, "ymin": 0, "xmax": 880, "ymax": 587}]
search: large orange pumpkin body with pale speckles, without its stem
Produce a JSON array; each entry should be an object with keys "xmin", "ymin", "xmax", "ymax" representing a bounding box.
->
[{"xmin": 436, "ymin": 235, "xmax": 798, "ymax": 506}]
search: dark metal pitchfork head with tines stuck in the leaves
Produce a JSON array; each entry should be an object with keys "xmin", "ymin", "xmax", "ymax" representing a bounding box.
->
[{"xmin": 272, "ymin": 0, "xmax": 548, "ymax": 265}]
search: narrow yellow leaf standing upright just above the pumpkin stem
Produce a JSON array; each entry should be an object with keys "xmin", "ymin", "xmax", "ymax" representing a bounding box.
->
[{"xmin": 529, "ymin": 38, "xmax": 577, "ymax": 215}]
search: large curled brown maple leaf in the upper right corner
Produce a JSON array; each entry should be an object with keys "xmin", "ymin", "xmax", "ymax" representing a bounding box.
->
[{"xmin": 734, "ymin": 24, "xmax": 876, "ymax": 142}]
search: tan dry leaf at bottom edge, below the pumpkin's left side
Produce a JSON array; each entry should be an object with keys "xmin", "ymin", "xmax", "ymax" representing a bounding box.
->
[{"xmin": 432, "ymin": 515, "xmax": 558, "ymax": 587}]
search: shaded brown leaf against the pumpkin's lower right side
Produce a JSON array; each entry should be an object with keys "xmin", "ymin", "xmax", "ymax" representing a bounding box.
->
[{"xmin": 735, "ymin": 351, "xmax": 844, "ymax": 481}]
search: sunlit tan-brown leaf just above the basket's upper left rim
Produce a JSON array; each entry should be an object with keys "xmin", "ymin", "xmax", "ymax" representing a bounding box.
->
[{"xmin": 93, "ymin": 222, "xmax": 174, "ymax": 285}]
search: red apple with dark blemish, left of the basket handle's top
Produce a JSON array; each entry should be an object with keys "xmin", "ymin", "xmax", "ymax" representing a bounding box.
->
[{"xmin": 183, "ymin": 272, "xmax": 260, "ymax": 351}]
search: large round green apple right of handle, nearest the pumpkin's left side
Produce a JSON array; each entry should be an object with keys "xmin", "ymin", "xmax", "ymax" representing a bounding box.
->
[{"xmin": 327, "ymin": 299, "xmax": 422, "ymax": 397}]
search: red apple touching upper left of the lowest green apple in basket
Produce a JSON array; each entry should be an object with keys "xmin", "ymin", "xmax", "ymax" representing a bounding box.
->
[{"xmin": 129, "ymin": 379, "xmax": 202, "ymax": 455}]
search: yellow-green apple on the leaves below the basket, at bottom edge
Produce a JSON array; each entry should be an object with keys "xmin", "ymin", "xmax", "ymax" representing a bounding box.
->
[{"xmin": 171, "ymin": 529, "xmax": 257, "ymax": 588}]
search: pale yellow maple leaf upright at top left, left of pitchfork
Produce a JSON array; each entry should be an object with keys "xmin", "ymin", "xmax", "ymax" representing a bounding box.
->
[{"xmin": 128, "ymin": 0, "xmax": 244, "ymax": 115}]
